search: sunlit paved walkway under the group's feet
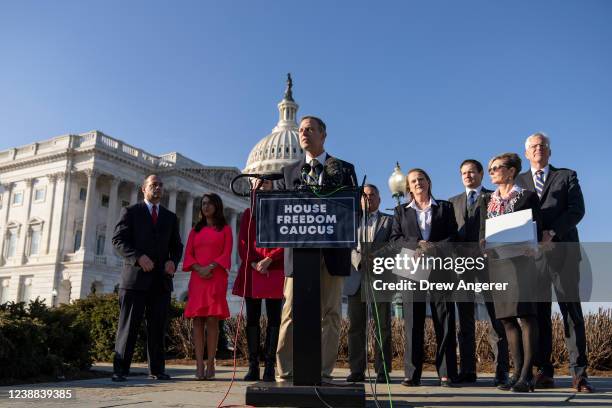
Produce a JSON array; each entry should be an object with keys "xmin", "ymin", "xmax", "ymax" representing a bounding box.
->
[{"xmin": 0, "ymin": 364, "xmax": 612, "ymax": 408}]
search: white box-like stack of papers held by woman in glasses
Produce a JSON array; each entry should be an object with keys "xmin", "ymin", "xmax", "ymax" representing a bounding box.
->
[{"xmin": 485, "ymin": 208, "xmax": 538, "ymax": 259}]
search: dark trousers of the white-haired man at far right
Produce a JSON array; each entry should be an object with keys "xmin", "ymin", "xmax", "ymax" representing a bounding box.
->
[{"xmin": 534, "ymin": 259, "xmax": 588, "ymax": 378}]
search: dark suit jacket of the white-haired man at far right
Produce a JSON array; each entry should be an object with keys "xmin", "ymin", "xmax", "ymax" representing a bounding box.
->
[{"xmin": 516, "ymin": 165, "xmax": 584, "ymax": 242}]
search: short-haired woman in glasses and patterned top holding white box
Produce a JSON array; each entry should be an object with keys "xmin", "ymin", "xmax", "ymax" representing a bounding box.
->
[{"xmin": 481, "ymin": 153, "xmax": 542, "ymax": 392}]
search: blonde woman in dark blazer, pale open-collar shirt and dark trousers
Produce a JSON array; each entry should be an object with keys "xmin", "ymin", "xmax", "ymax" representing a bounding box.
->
[{"xmin": 390, "ymin": 169, "xmax": 457, "ymax": 387}]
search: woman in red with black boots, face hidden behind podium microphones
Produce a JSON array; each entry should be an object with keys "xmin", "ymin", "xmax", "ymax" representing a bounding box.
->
[{"xmin": 232, "ymin": 180, "xmax": 285, "ymax": 381}]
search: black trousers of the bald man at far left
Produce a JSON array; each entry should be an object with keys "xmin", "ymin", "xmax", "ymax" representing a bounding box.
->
[{"xmin": 113, "ymin": 289, "xmax": 170, "ymax": 375}]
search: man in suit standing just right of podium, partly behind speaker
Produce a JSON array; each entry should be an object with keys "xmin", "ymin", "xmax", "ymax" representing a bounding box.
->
[{"xmin": 344, "ymin": 184, "xmax": 394, "ymax": 383}]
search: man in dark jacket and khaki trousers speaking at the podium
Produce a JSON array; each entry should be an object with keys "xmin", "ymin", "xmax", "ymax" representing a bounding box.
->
[{"xmin": 276, "ymin": 116, "xmax": 357, "ymax": 381}]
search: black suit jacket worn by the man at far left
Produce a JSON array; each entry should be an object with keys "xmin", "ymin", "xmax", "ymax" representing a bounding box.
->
[{"xmin": 113, "ymin": 202, "xmax": 183, "ymax": 292}]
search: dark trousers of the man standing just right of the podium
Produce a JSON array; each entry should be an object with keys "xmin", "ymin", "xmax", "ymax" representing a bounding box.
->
[{"xmin": 348, "ymin": 288, "xmax": 392, "ymax": 374}]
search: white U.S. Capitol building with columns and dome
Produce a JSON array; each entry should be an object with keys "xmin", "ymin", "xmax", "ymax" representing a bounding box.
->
[{"xmin": 0, "ymin": 76, "xmax": 303, "ymax": 306}]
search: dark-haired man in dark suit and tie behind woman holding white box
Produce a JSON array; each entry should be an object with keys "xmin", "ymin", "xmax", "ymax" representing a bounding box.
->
[{"xmin": 449, "ymin": 159, "xmax": 509, "ymax": 386}]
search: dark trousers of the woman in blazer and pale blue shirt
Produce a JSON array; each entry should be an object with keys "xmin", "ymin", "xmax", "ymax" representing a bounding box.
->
[{"xmin": 403, "ymin": 291, "xmax": 457, "ymax": 381}]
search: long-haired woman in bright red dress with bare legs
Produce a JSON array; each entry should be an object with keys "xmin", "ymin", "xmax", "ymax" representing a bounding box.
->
[{"xmin": 183, "ymin": 193, "xmax": 232, "ymax": 380}]
